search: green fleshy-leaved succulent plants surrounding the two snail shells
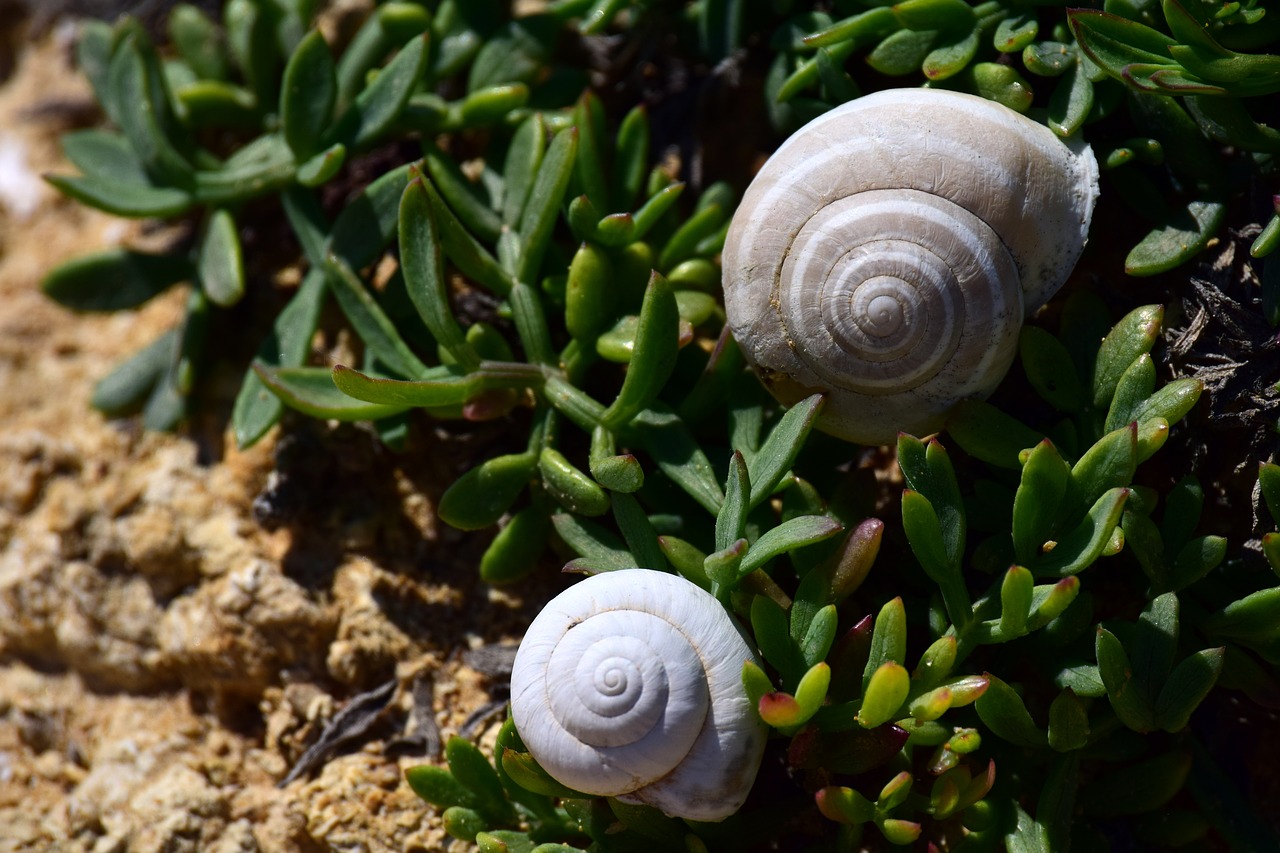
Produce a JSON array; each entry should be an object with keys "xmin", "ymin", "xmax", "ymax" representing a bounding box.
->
[{"xmin": 35, "ymin": 0, "xmax": 1280, "ymax": 853}]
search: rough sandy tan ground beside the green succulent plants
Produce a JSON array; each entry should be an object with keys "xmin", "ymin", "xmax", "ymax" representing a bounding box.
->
[{"xmin": 0, "ymin": 14, "xmax": 557, "ymax": 853}]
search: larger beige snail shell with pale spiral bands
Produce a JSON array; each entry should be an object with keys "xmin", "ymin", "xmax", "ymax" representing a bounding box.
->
[{"xmin": 722, "ymin": 88, "xmax": 1098, "ymax": 443}]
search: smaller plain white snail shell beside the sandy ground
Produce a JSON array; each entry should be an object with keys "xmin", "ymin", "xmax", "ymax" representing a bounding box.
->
[{"xmin": 511, "ymin": 569, "xmax": 767, "ymax": 821}]
